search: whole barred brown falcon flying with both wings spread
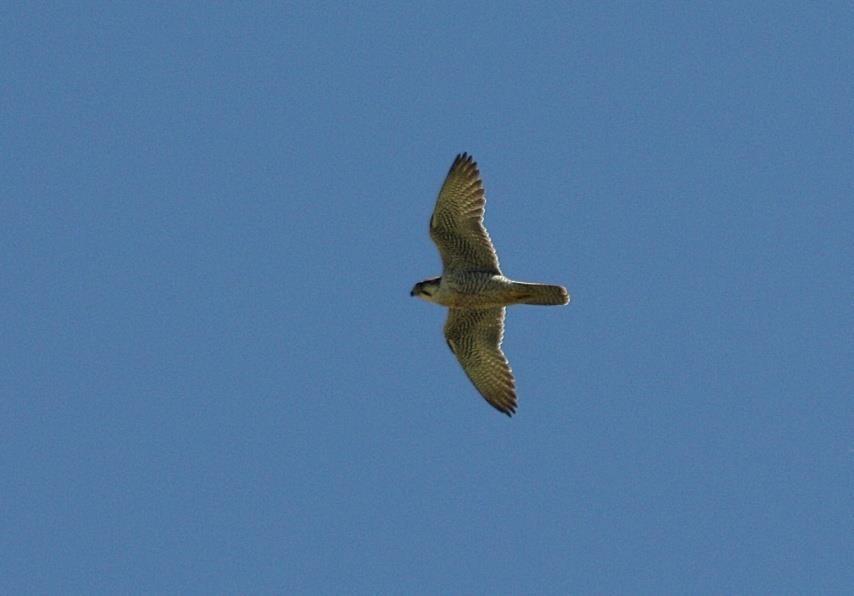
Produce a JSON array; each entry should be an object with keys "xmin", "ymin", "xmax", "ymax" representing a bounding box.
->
[{"xmin": 409, "ymin": 153, "xmax": 569, "ymax": 416}]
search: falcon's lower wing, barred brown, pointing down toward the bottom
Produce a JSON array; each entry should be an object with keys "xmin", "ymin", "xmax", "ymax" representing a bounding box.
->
[{"xmin": 445, "ymin": 307, "xmax": 516, "ymax": 416}]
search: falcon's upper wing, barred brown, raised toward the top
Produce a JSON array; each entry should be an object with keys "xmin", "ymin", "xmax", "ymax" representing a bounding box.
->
[{"xmin": 430, "ymin": 153, "xmax": 501, "ymax": 274}]
